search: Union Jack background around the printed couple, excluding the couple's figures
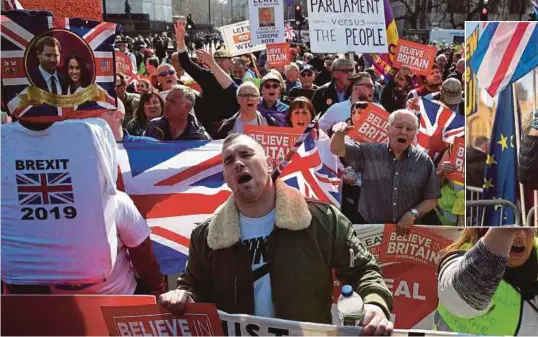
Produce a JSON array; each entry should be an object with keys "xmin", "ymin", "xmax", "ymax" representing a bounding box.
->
[{"xmin": 1, "ymin": 15, "xmax": 116, "ymax": 121}]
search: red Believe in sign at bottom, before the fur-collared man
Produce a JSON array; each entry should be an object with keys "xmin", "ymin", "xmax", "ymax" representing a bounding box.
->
[{"xmin": 101, "ymin": 303, "xmax": 223, "ymax": 336}]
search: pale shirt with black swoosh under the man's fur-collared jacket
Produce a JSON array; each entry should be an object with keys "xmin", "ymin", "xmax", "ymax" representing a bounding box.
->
[{"xmin": 239, "ymin": 209, "xmax": 275, "ymax": 317}]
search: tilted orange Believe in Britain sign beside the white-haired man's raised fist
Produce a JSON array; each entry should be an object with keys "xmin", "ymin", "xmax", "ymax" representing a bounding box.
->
[{"xmin": 349, "ymin": 104, "xmax": 389, "ymax": 143}]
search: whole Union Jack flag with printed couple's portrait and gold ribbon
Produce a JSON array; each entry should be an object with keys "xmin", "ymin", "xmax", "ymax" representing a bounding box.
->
[{"xmin": 2, "ymin": 16, "xmax": 116, "ymax": 122}]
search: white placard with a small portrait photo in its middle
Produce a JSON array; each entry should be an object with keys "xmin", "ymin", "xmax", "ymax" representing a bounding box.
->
[{"xmin": 248, "ymin": 0, "xmax": 286, "ymax": 44}]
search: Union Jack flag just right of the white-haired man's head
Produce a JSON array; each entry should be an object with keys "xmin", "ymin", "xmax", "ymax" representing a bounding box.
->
[{"xmin": 408, "ymin": 97, "xmax": 465, "ymax": 158}]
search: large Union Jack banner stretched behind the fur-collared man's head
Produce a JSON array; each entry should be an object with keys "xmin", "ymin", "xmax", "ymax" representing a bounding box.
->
[{"xmin": 118, "ymin": 138, "xmax": 340, "ymax": 275}]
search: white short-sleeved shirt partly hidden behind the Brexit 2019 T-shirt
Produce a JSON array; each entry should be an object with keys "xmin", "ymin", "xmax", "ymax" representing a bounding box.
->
[{"xmin": 50, "ymin": 191, "xmax": 151, "ymax": 295}]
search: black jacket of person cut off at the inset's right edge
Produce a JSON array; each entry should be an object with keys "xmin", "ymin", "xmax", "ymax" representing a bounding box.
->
[{"xmin": 517, "ymin": 135, "xmax": 538, "ymax": 190}]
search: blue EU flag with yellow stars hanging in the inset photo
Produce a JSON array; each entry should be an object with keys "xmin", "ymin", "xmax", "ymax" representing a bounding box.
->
[{"xmin": 483, "ymin": 85, "xmax": 519, "ymax": 226}]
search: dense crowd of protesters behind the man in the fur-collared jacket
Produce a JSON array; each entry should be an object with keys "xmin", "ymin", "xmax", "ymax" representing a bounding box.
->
[{"xmin": 111, "ymin": 23, "xmax": 464, "ymax": 225}]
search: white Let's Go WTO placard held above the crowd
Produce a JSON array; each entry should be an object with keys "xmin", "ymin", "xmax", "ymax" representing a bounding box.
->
[{"xmin": 220, "ymin": 21, "xmax": 264, "ymax": 56}]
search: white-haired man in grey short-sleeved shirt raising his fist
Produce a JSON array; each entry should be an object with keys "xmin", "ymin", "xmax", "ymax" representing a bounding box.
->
[{"xmin": 331, "ymin": 110, "xmax": 441, "ymax": 232}]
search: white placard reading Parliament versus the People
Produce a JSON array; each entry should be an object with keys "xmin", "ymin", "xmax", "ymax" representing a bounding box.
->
[{"xmin": 307, "ymin": 0, "xmax": 388, "ymax": 53}]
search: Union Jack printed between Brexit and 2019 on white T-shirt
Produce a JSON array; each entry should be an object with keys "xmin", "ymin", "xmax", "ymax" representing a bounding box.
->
[{"xmin": 16, "ymin": 172, "xmax": 75, "ymax": 205}]
